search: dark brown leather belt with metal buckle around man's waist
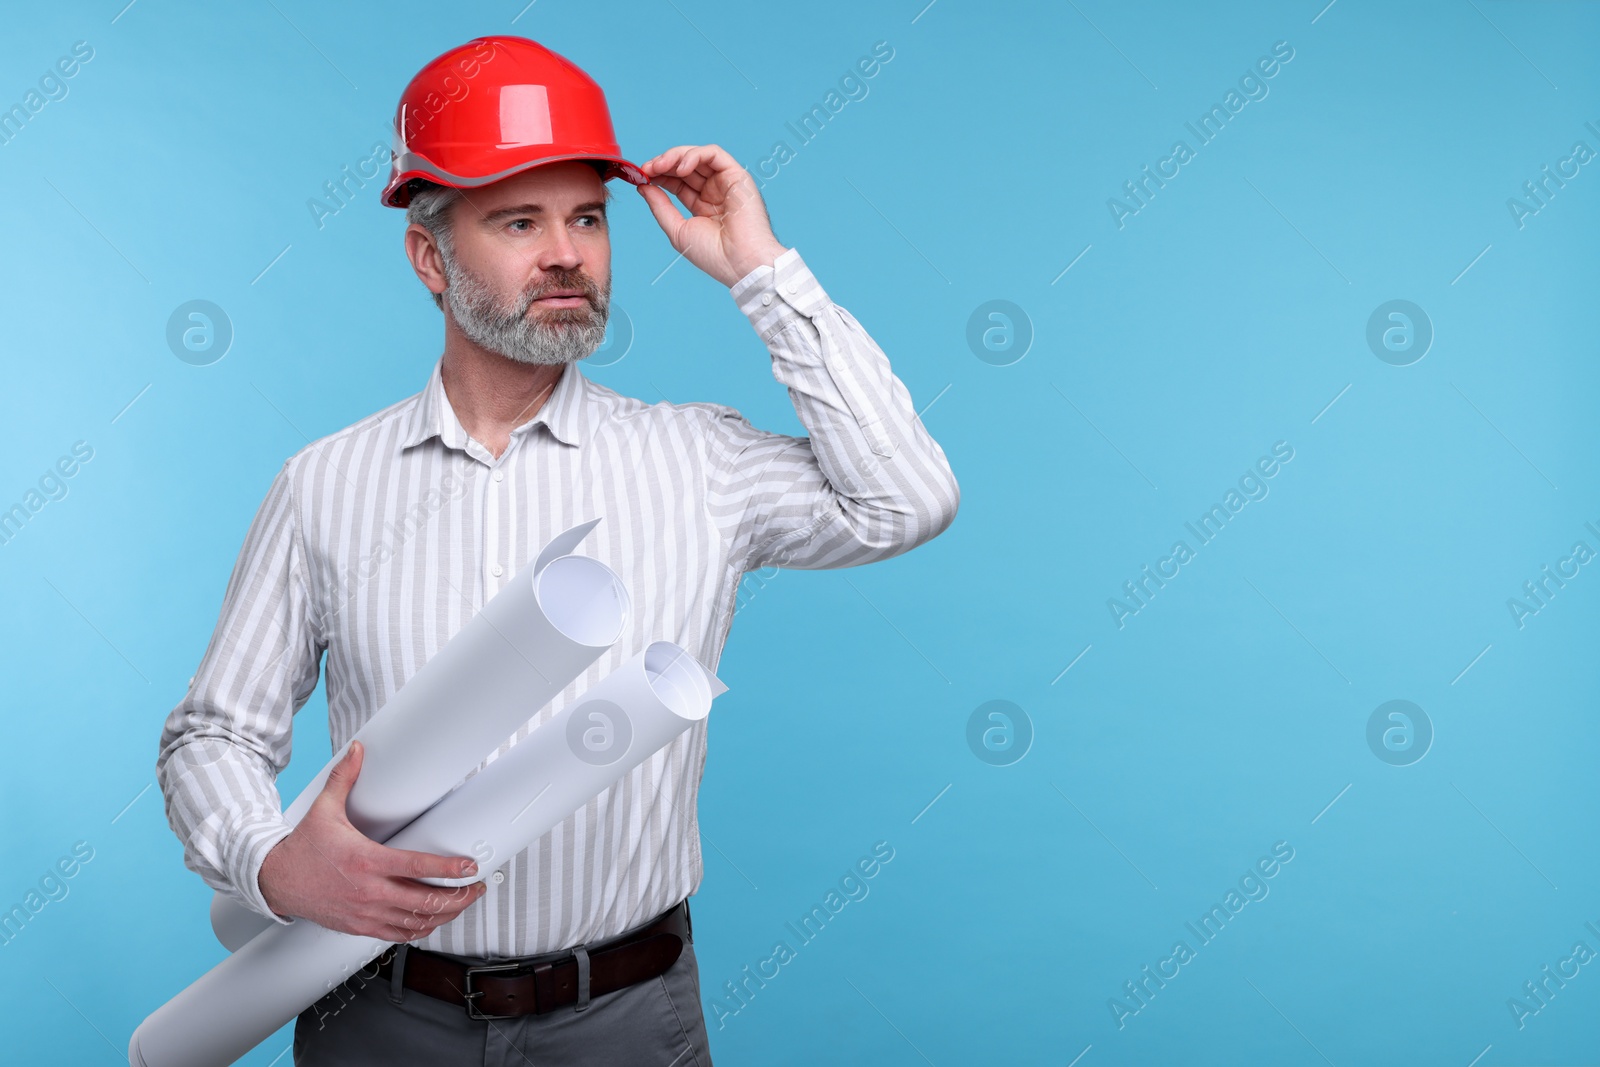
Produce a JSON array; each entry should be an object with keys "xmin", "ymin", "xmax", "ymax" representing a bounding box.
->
[{"xmin": 378, "ymin": 901, "xmax": 694, "ymax": 1019}]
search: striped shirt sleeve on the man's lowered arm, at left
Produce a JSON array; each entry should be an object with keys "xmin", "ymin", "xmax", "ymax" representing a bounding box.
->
[{"xmin": 155, "ymin": 461, "xmax": 326, "ymax": 923}]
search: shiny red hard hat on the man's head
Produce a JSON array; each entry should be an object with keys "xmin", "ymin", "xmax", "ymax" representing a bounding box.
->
[{"xmin": 384, "ymin": 37, "xmax": 650, "ymax": 208}]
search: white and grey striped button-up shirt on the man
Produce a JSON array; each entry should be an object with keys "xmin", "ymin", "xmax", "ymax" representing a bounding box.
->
[{"xmin": 157, "ymin": 248, "xmax": 960, "ymax": 958}]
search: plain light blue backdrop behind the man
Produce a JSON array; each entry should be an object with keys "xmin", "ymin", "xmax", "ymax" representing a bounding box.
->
[{"xmin": 0, "ymin": 0, "xmax": 1600, "ymax": 1067}]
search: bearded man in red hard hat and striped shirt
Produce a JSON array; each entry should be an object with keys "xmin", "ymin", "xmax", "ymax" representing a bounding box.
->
[{"xmin": 157, "ymin": 37, "xmax": 958, "ymax": 1067}]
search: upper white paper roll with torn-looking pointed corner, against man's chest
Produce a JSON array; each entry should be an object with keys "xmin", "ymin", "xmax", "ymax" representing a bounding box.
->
[{"xmin": 211, "ymin": 518, "xmax": 630, "ymax": 950}]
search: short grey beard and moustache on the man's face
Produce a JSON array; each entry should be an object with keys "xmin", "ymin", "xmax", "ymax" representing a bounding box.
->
[{"xmin": 442, "ymin": 256, "xmax": 611, "ymax": 365}]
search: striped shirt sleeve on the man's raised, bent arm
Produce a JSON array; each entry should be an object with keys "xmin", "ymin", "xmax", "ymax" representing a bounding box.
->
[{"xmin": 707, "ymin": 248, "xmax": 960, "ymax": 571}]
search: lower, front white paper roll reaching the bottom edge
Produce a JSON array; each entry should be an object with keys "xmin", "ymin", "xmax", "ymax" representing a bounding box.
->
[{"xmin": 128, "ymin": 641, "xmax": 726, "ymax": 1067}]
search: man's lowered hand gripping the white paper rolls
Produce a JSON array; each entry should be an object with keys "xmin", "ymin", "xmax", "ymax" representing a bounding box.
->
[{"xmin": 259, "ymin": 741, "xmax": 486, "ymax": 942}]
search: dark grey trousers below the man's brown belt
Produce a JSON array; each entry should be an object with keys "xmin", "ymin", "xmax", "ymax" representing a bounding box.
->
[{"xmin": 294, "ymin": 927, "xmax": 710, "ymax": 1067}]
